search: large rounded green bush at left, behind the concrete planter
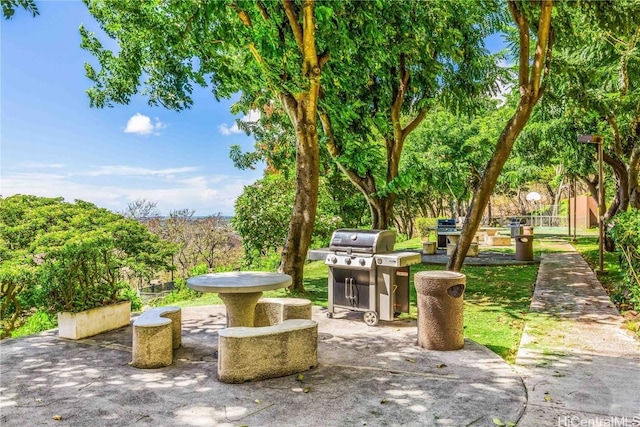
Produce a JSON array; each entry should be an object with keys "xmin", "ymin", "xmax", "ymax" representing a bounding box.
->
[{"xmin": 0, "ymin": 195, "xmax": 174, "ymax": 335}]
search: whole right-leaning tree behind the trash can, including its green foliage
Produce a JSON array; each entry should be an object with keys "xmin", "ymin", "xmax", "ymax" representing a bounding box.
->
[{"xmin": 447, "ymin": 0, "xmax": 640, "ymax": 271}]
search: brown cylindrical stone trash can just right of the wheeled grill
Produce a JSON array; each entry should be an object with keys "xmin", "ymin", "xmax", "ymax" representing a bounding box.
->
[{"xmin": 413, "ymin": 271, "xmax": 467, "ymax": 351}]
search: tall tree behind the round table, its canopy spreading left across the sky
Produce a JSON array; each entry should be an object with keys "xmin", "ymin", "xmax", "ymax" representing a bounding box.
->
[{"xmin": 80, "ymin": 0, "xmax": 342, "ymax": 291}]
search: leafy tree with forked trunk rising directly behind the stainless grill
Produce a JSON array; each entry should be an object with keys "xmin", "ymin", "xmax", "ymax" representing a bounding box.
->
[{"xmin": 319, "ymin": 1, "xmax": 503, "ymax": 229}]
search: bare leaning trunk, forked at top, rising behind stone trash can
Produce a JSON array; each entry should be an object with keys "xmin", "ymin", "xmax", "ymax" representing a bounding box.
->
[{"xmin": 447, "ymin": 0, "xmax": 553, "ymax": 271}]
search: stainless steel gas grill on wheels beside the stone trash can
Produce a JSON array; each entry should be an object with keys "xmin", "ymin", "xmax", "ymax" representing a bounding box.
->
[{"xmin": 309, "ymin": 229, "xmax": 421, "ymax": 326}]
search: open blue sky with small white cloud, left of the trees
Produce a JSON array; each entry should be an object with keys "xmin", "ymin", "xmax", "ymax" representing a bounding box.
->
[{"xmin": 0, "ymin": 1, "xmax": 262, "ymax": 215}]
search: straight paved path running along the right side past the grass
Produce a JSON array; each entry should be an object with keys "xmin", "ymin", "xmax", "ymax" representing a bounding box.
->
[{"xmin": 516, "ymin": 243, "xmax": 640, "ymax": 427}]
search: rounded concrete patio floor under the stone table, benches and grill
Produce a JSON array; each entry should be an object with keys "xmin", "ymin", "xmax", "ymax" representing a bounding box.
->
[{"xmin": 0, "ymin": 306, "xmax": 526, "ymax": 427}]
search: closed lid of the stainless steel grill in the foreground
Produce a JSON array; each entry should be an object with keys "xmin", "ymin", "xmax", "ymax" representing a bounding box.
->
[{"xmin": 329, "ymin": 228, "xmax": 396, "ymax": 254}]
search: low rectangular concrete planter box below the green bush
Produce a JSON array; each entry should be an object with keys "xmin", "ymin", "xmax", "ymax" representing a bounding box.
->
[{"xmin": 58, "ymin": 301, "xmax": 131, "ymax": 340}]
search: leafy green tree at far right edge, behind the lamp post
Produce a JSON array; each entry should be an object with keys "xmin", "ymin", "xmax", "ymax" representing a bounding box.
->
[{"xmin": 549, "ymin": 2, "xmax": 640, "ymax": 218}]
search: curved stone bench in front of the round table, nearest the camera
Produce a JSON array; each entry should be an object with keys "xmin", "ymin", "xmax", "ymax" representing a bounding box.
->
[{"xmin": 218, "ymin": 319, "xmax": 318, "ymax": 383}]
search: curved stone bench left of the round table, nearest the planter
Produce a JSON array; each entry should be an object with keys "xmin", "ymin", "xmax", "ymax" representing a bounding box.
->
[{"xmin": 131, "ymin": 306, "xmax": 182, "ymax": 369}]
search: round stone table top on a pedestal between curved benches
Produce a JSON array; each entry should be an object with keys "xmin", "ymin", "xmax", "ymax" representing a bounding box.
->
[{"xmin": 187, "ymin": 271, "xmax": 291, "ymax": 293}]
